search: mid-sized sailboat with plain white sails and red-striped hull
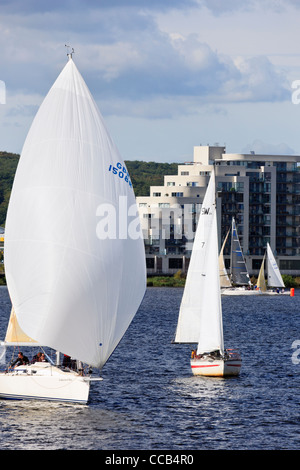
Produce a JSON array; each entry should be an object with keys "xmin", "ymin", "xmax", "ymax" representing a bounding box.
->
[{"xmin": 174, "ymin": 170, "xmax": 241, "ymax": 377}]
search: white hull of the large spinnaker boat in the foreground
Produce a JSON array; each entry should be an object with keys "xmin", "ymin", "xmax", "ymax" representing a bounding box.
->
[{"xmin": 0, "ymin": 363, "xmax": 95, "ymax": 404}]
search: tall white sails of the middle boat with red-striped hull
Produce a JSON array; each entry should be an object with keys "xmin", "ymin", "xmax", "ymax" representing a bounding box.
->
[{"xmin": 175, "ymin": 171, "xmax": 224, "ymax": 354}]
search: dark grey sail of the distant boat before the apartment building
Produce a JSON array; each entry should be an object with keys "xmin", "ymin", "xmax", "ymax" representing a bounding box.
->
[{"xmin": 230, "ymin": 219, "xmax": 251, "ymax": 286}]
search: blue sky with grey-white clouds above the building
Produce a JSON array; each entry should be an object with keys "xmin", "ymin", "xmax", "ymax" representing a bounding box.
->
[{"xmin": 0, "ymin": 0, "xmax": 300, "ymax": 163}]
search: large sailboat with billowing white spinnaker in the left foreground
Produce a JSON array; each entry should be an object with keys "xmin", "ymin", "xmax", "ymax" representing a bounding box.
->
[{"xmin": 0, "ymin": 54, "xmax": 146, "ymax": 403}]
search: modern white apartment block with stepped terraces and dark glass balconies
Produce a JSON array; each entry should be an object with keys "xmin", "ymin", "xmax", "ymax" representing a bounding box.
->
[{"xmin": 137, "ymin": 145, "xmax": 300, "ymax": 276}]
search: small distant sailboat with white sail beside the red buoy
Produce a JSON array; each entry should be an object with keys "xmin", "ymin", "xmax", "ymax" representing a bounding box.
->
[{"xmin": 257, "ymin": 243, "xmax": 290, "ymax": 295}]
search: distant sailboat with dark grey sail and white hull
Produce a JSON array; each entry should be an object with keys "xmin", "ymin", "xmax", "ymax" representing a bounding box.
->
[{"xmin": 220, "ymin": 218, "xmax": 261, "ymax": 295}]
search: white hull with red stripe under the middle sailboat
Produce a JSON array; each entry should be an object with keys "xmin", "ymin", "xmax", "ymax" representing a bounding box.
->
[{"xmin": 191, "ymin": 354, "xmax": 242, "ymax": 377}]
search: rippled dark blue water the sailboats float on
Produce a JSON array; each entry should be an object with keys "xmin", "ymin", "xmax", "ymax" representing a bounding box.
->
[{"xmin": 0, "ymin": 287, "xmax": 300, "ymax": 451}]
